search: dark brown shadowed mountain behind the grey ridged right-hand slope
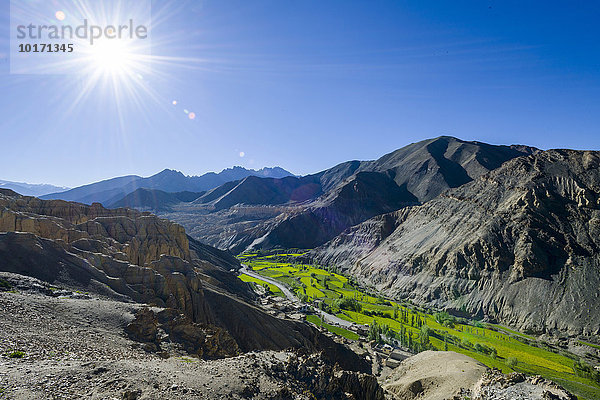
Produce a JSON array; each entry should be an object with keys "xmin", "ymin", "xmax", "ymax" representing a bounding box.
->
[{"xmin": 164, "ymin": 136, "xmax": 537, "ymax": 252}]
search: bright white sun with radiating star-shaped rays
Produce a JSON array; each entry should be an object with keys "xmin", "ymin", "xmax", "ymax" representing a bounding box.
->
[{"xmin": 11, "ymin": 0, "xmax": 202, "ymax": 127}]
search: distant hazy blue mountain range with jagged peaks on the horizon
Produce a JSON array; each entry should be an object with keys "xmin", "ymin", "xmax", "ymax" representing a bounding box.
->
[{"xmin": 41, "ymin": 167, "xmax": 292, "ymax": 205}]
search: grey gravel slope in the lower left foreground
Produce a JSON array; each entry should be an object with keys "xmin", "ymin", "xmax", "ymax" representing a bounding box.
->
[{"xmin": 0, "ymin": 276, "xmax": 310, "ymax": 400}]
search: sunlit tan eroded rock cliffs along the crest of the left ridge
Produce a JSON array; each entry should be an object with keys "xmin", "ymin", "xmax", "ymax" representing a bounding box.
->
[{"xmin": 0, "ymin": 191, "xmax": 190, "ymax": 266}]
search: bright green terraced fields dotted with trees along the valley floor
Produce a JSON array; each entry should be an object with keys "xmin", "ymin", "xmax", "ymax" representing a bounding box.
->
[{"xmin": 239, "ymin": 252, "xmax": 600, "ymax": 399}]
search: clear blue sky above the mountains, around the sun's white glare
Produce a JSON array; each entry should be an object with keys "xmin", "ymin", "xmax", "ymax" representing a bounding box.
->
[{"xmin": 0, "ymin": 0, "xmax": 600, "ymax": 186}]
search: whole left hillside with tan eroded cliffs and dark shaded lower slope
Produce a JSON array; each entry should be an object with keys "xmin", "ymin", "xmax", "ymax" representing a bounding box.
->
[{"xmin": 0, "ymin": 190, "xmax": 370, "ymax": 371}]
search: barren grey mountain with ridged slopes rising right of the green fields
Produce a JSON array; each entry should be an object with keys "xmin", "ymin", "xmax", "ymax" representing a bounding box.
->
[{"xmin": 309, "ymin": 150, "xmax": 600, "ymax": 335}]
